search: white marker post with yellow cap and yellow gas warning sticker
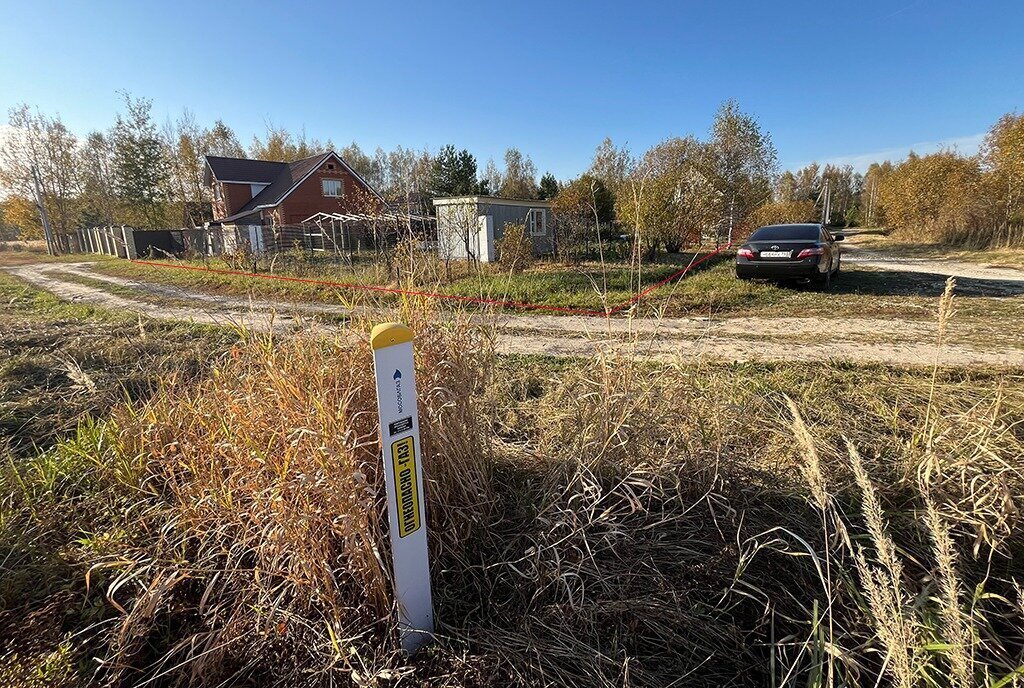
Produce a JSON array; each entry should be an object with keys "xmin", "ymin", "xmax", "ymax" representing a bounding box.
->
[{"xmin": 370, "ymin": 323, "xmax": 434, "ymax": 653}]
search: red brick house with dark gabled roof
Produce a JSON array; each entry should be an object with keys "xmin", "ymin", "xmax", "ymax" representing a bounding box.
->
[{"xmin": 204, "ymin": 151, "xmax": 387, "ymax": 228}]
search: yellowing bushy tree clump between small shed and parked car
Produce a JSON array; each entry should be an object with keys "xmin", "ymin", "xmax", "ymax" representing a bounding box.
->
[{"xmin": 552, "ymin": 100, "xmax": 778, "ymax": 259}]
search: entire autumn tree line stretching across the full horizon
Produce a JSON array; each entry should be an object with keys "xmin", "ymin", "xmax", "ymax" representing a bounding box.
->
[{"xmin": 0, "ymin": 93, "xmax": 1024, "ymax": 250}]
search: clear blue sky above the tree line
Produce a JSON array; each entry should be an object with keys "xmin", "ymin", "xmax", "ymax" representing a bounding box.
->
[{"xmin": 0, "ymin": 0, "xmax": 1024, "ymax": 178}]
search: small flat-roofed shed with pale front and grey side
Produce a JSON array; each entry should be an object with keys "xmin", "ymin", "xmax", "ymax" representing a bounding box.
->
[{"xmin": 434, "ymin": 196, "xmax": 554, "ymax": 263}]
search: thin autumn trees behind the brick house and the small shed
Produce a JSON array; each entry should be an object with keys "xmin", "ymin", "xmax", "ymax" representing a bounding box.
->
[{"xmin": 0, "ymin": 93, "xmax": 554, "ymax": 237}]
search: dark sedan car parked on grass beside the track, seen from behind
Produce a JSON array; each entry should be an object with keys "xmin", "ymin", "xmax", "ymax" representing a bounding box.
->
[{"xmin": 736, "ymin": 224, "xmax": 846, "ymax": 289}]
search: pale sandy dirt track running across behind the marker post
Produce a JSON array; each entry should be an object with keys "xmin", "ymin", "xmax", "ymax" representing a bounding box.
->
[{"xmin": 5, "ymin": 261, "xmax": 1024, "ymax": 366}]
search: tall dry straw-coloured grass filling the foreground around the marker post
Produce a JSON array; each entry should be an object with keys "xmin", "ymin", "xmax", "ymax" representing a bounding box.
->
[{"xmin": 6, "ymin": 288, "xmax": 1024, "ymax": 686}]
